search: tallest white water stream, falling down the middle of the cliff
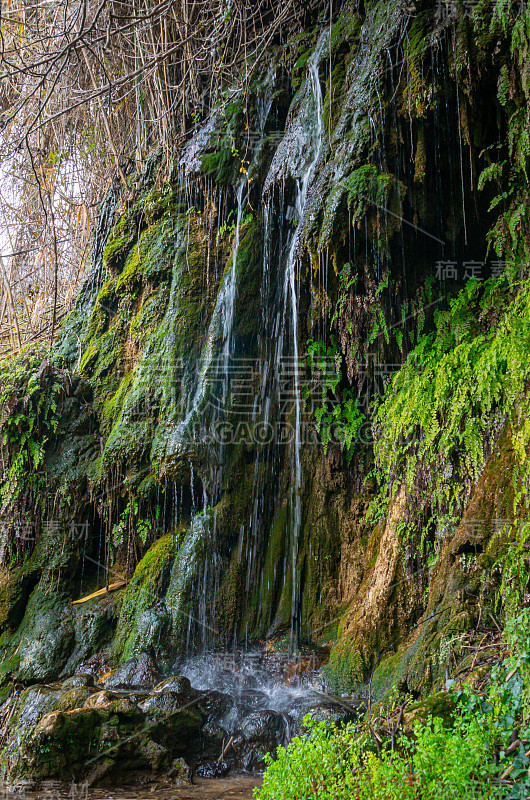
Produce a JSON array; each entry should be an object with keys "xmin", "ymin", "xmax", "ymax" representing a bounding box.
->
[{"xmin": 234, "ymin": 29, "xmax": 329, "ymax": 651}]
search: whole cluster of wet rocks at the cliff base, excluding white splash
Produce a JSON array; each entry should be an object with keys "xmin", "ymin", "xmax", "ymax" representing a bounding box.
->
[{"xmin": 0, "ymin": 655, "xmax": 320, "ymax": 786}]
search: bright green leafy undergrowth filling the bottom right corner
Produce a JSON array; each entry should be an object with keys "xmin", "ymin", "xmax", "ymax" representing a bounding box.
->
[{"xmin": 254, "ymin": 610, "xmax": 530, "ymax": 800}]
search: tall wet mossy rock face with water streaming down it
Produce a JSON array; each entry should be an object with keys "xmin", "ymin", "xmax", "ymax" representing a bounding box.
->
[{"xmin": 0, "ymin": 0, "xmax": 530, "ymax": 780}]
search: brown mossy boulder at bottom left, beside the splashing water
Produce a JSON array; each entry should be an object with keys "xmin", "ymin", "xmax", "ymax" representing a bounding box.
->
[{"xmin": 2, "ymin": 676, "xmax": 212, "ymax": 785}]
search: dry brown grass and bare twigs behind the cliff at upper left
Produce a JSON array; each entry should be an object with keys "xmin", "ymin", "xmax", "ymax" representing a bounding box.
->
[{"xmin": 0, "ymin": 0, "xmax": 327, "ymax": 352}]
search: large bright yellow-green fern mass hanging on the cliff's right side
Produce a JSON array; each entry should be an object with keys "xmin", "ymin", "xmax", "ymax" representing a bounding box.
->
[{"xmin": 374, "ymin": 278, "xmax": 530, "ymax": 532}]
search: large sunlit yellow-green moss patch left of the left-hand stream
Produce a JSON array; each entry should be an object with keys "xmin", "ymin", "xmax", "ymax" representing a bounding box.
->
[{"xmin": 80, "ymin": 199, "xmax": 199, "ymax": 487}]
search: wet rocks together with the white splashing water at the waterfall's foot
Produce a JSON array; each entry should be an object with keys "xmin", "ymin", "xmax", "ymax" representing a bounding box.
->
[{"xmin": 0, "ymin": 651, "xmax": 358, "ymax": 786}]
